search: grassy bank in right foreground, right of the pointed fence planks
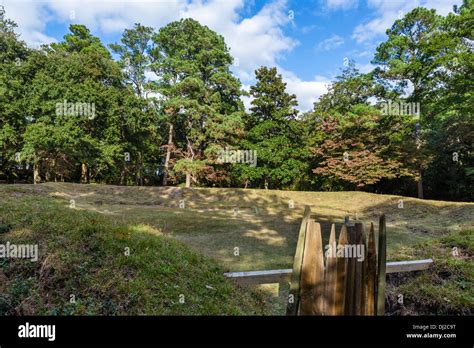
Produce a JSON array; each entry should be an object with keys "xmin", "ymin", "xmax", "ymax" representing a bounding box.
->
[{"xmin": 387, "ymin": 230, "xmax": 474, "ymax": 315}]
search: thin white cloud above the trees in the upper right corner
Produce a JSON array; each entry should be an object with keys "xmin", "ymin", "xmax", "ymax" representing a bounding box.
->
[{"xmin": 352, "ymin": 0, "xmax": 462, "ymax": 43}]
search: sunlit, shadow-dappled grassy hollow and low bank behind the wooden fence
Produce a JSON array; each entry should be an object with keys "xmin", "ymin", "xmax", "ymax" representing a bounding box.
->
[{"xmin": 6, "ymin": 183, "xmax": 474, "ymax": 271}]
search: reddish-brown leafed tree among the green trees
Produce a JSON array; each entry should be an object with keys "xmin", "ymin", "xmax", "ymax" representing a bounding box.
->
[{"xmin": 313, "ymin": 104, "xmax": 410, "ymax": 189}]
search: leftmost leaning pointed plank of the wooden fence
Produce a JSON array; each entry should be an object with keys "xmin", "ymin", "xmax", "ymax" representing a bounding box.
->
[{"xmin": 286, "ymin": 206, "xmax": 311, "ymax": 315}]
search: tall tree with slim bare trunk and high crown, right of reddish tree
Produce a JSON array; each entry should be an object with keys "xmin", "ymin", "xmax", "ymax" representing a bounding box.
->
[{"xmin": 373, "ymin": 7, "xmax": 453, "ymax": 198}]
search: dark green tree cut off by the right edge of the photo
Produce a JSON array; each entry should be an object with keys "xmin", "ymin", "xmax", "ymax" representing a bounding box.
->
[{"xmin": 425, "ymin": 1, "xmax": 474, "ymax": 201}]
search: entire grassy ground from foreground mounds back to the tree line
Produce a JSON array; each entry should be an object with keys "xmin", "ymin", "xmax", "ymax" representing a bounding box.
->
[{"xmin": 0, "ymin": 183, "xmax": 474, "ymax": 315}]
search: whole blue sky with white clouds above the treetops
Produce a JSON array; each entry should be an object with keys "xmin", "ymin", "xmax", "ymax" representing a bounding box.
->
[{"xmin": 0, "ymin": 0, "xmax": 462, "ymax": 110}]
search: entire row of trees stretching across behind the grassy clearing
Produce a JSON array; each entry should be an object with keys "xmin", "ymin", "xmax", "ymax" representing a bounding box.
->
[{"xmin": 0, "ymin": 0, "xmax": 474, "ymax": 201}]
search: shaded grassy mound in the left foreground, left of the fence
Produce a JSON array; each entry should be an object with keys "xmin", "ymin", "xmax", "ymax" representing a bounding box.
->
[{"xmin": 0, "ymin": 193, "xmax": 264, "ymax": 315}]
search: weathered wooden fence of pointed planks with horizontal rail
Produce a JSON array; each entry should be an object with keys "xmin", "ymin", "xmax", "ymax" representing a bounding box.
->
[{"xmin": 226, "ymin": 207, "xmax": 433, "ymax": 315}]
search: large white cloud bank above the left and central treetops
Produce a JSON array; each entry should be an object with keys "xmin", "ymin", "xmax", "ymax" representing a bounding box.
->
[{"xmin": 1, "ymin": 0, "xmax": 330, "ymax": 111}]
